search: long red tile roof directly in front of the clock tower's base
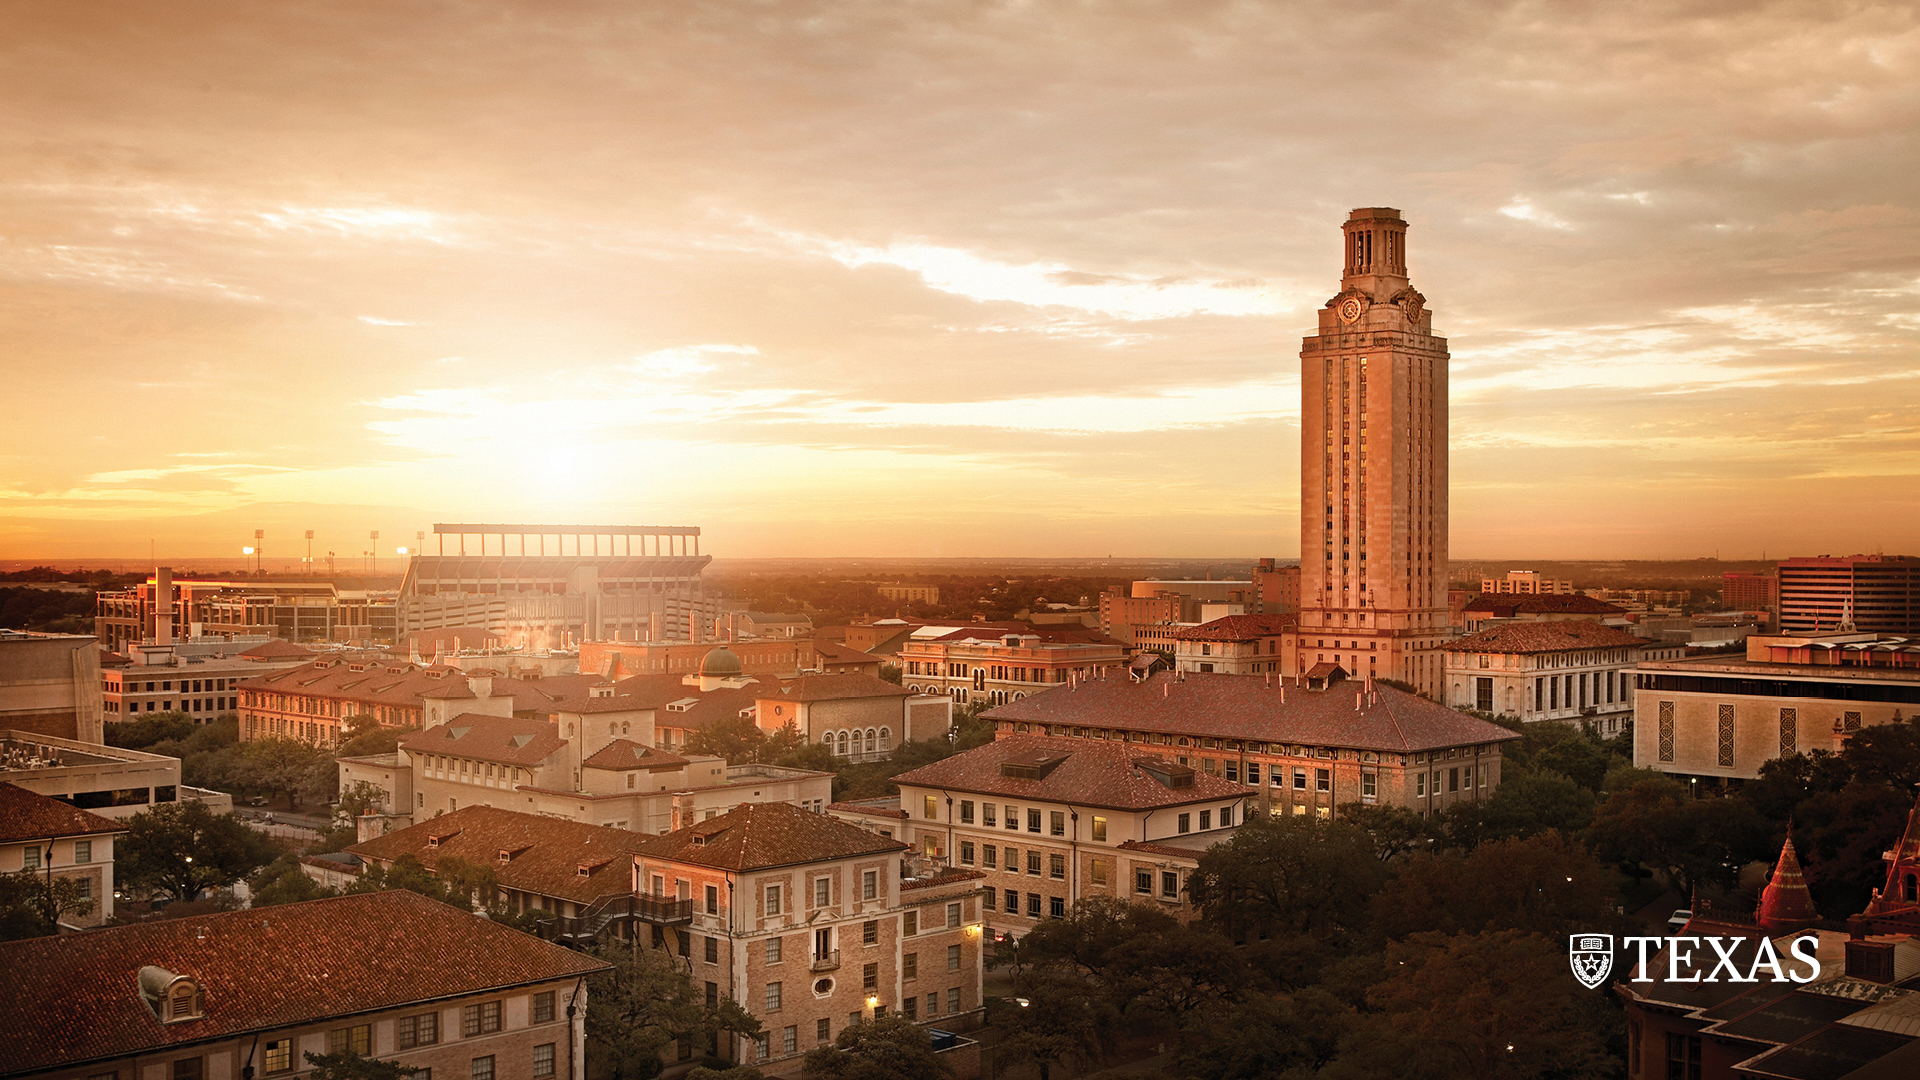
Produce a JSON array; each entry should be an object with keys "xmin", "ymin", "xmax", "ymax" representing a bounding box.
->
[{"xmin": 985, "ymin": 673, "xmax": 1521, "ymax": 753}]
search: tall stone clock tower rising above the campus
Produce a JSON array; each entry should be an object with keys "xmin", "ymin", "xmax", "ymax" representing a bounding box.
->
[{"xmin": 1298, "ymin": 208, "xmax": 1448, "ymax": 698}]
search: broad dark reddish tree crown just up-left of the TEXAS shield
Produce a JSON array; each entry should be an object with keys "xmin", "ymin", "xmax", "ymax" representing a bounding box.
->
[{"xmin": 1371, "ymin": 832, "xmax": 1613, "ymax": 940}]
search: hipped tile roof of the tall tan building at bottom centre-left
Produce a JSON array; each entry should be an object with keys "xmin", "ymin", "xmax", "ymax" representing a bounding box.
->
[{"xmin": 625, "ymin": 803, "xmax": 906, "ymax": 871}]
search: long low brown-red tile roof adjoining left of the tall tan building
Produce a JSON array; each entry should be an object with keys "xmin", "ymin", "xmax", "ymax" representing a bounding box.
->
[{"xmin": 348, "ymin": 807, "xmax": 647, "ymax": 903}]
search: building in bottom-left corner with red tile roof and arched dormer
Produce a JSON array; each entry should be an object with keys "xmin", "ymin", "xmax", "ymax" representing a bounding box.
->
[{"xmin": 0, "ymin": 890, "xmax": 609, "ymax": 1080}]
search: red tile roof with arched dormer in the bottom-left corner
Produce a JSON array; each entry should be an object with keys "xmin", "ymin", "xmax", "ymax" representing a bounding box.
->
[{"xmin": 0, "ymin": 890, "xmax": 609, "ymax": 1074}]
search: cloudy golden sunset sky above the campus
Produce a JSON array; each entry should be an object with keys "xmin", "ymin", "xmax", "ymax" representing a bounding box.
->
[{"xmin": 0, "ymin": 0, "xmax": 1920, "ymax": 561}]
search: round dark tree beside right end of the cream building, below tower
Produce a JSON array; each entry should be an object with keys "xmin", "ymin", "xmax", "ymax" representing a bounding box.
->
[{"xmin": 1187, "ymin": 815, "xmax": 1386, "ymax": 938}]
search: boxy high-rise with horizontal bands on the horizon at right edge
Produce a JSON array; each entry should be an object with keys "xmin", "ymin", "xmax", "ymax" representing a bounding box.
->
[{"xmin": 1778, "ymin": 555, "xmax": 1920, "ymax": 634}]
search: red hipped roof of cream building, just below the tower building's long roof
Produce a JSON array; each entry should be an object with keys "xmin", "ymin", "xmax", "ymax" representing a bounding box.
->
[{"xmin": 893, "ymin": 730, "xmax": 1250, "ymax": 809}]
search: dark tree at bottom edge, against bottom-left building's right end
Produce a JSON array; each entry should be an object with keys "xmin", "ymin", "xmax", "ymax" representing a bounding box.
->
[{"xmin": 586, "ymin": 942, "xmax": 760, "ymax": 1080}]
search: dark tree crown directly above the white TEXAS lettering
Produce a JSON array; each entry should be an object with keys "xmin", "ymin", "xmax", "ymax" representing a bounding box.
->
[{"xmin": 1588, "ymin": 778, "xmax": 1768, "ymax": 896}]
